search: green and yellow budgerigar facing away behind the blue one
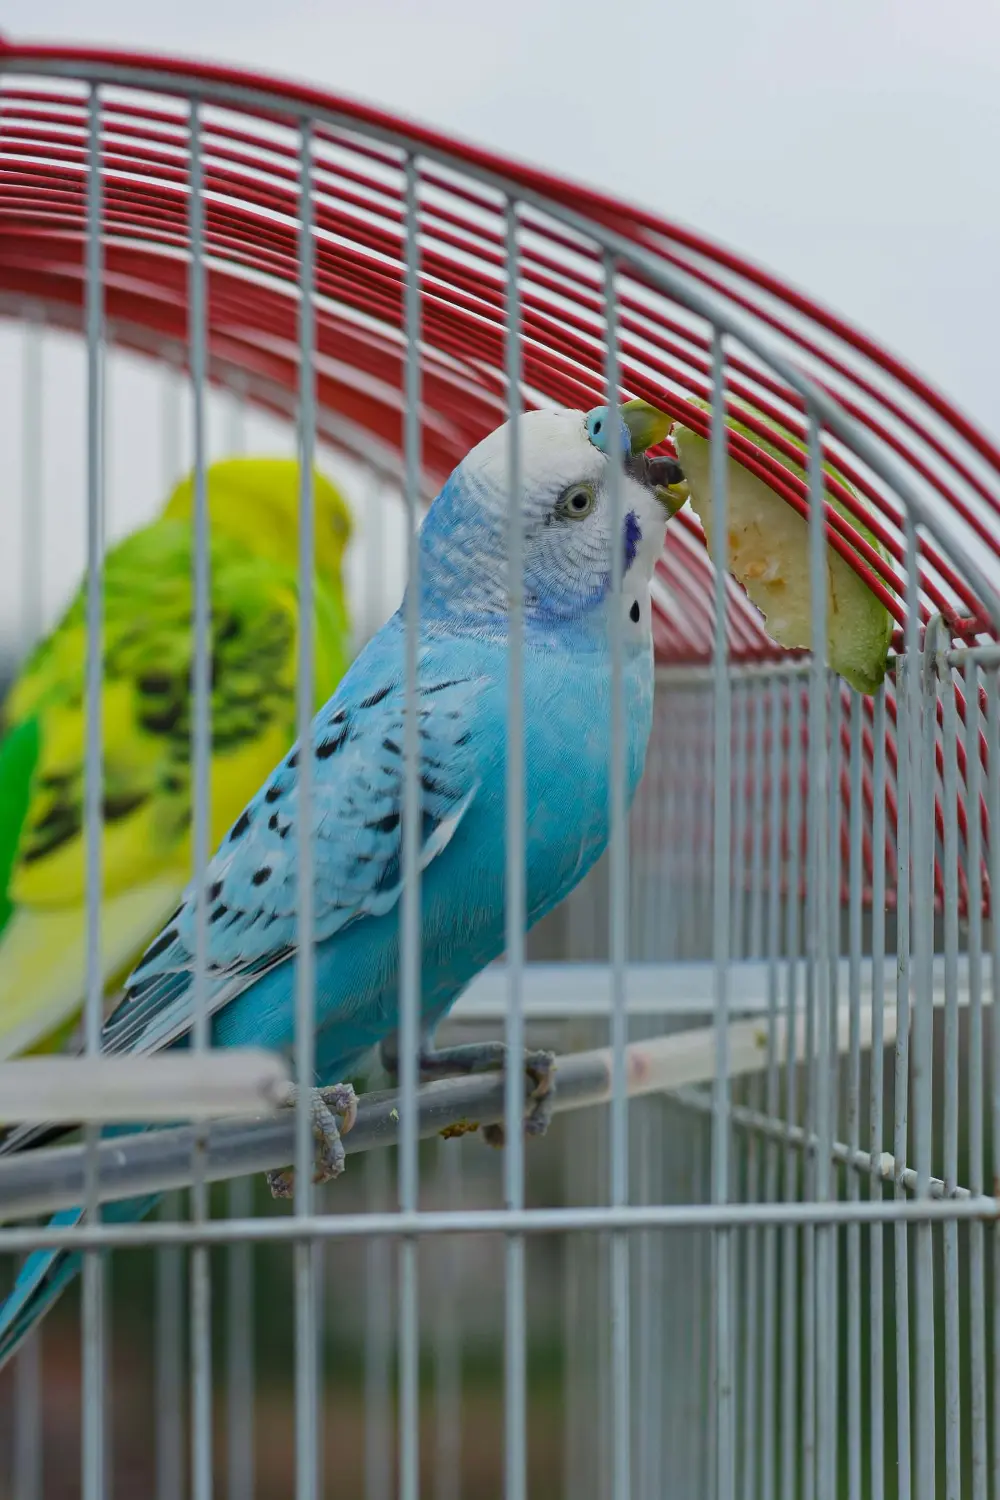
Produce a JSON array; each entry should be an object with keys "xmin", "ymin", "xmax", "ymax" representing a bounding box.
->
[{"xmin": 0, "ymin": 458, "xmax": 351, "ymax": 1059}]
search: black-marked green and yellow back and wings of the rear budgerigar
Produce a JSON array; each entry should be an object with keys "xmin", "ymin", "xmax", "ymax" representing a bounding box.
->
[{"xmin": 7, "ymin": 521, "xmax": 348, "ymax": 903}]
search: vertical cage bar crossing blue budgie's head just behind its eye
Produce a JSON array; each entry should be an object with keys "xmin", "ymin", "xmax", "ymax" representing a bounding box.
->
[{"xmin": 504, "ymin": 201, "xmax": 528, "ymax": 1500}]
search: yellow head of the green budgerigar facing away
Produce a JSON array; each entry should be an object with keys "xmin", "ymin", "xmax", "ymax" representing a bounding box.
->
[{"xmin": 163, "ymin": 458, "xmax": 352, "ymax": 582}]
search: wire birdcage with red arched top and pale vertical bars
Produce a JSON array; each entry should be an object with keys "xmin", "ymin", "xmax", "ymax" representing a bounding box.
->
[{"xmin": 0, "ymin": 32, "xmax": 1000, "ymax": 1500}]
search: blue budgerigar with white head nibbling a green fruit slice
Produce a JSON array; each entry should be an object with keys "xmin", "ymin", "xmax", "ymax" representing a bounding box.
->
[{"xmin": 0, "ymin": 402, "xmax": 676, "ymax": 1362}]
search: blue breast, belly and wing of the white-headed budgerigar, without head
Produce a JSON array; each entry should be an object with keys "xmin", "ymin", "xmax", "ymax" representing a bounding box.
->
[{"xmin": 106, "ymin": 609, "xmax": 652, "ymax": 1082}]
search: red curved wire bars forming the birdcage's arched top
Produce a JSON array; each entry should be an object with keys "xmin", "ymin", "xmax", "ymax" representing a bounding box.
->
[{"xmin": 0, "ymin": 48, "xmax": 1000, "ymax": 936}]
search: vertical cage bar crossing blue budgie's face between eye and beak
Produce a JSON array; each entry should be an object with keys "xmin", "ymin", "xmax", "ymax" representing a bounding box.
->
[{"xmin": 604, "ymin": 255, "xmax": 631, "ymax": 1500}]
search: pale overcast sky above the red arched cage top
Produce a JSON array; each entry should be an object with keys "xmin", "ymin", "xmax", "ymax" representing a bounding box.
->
[{"xmin": 0, "ymin": 0, "xmax": 1000, "ymax": 645}]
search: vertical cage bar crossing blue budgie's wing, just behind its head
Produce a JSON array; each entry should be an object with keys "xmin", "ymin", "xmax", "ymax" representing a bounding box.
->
[{"xmin": 399, "ymin": 146, "xmax": 421, "ymax": 1500}]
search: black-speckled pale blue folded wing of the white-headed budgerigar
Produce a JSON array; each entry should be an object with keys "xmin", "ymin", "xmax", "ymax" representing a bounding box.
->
[{"xmin": 105, "ymin": 663, "xmax": 483, "ymax": 1052}]
